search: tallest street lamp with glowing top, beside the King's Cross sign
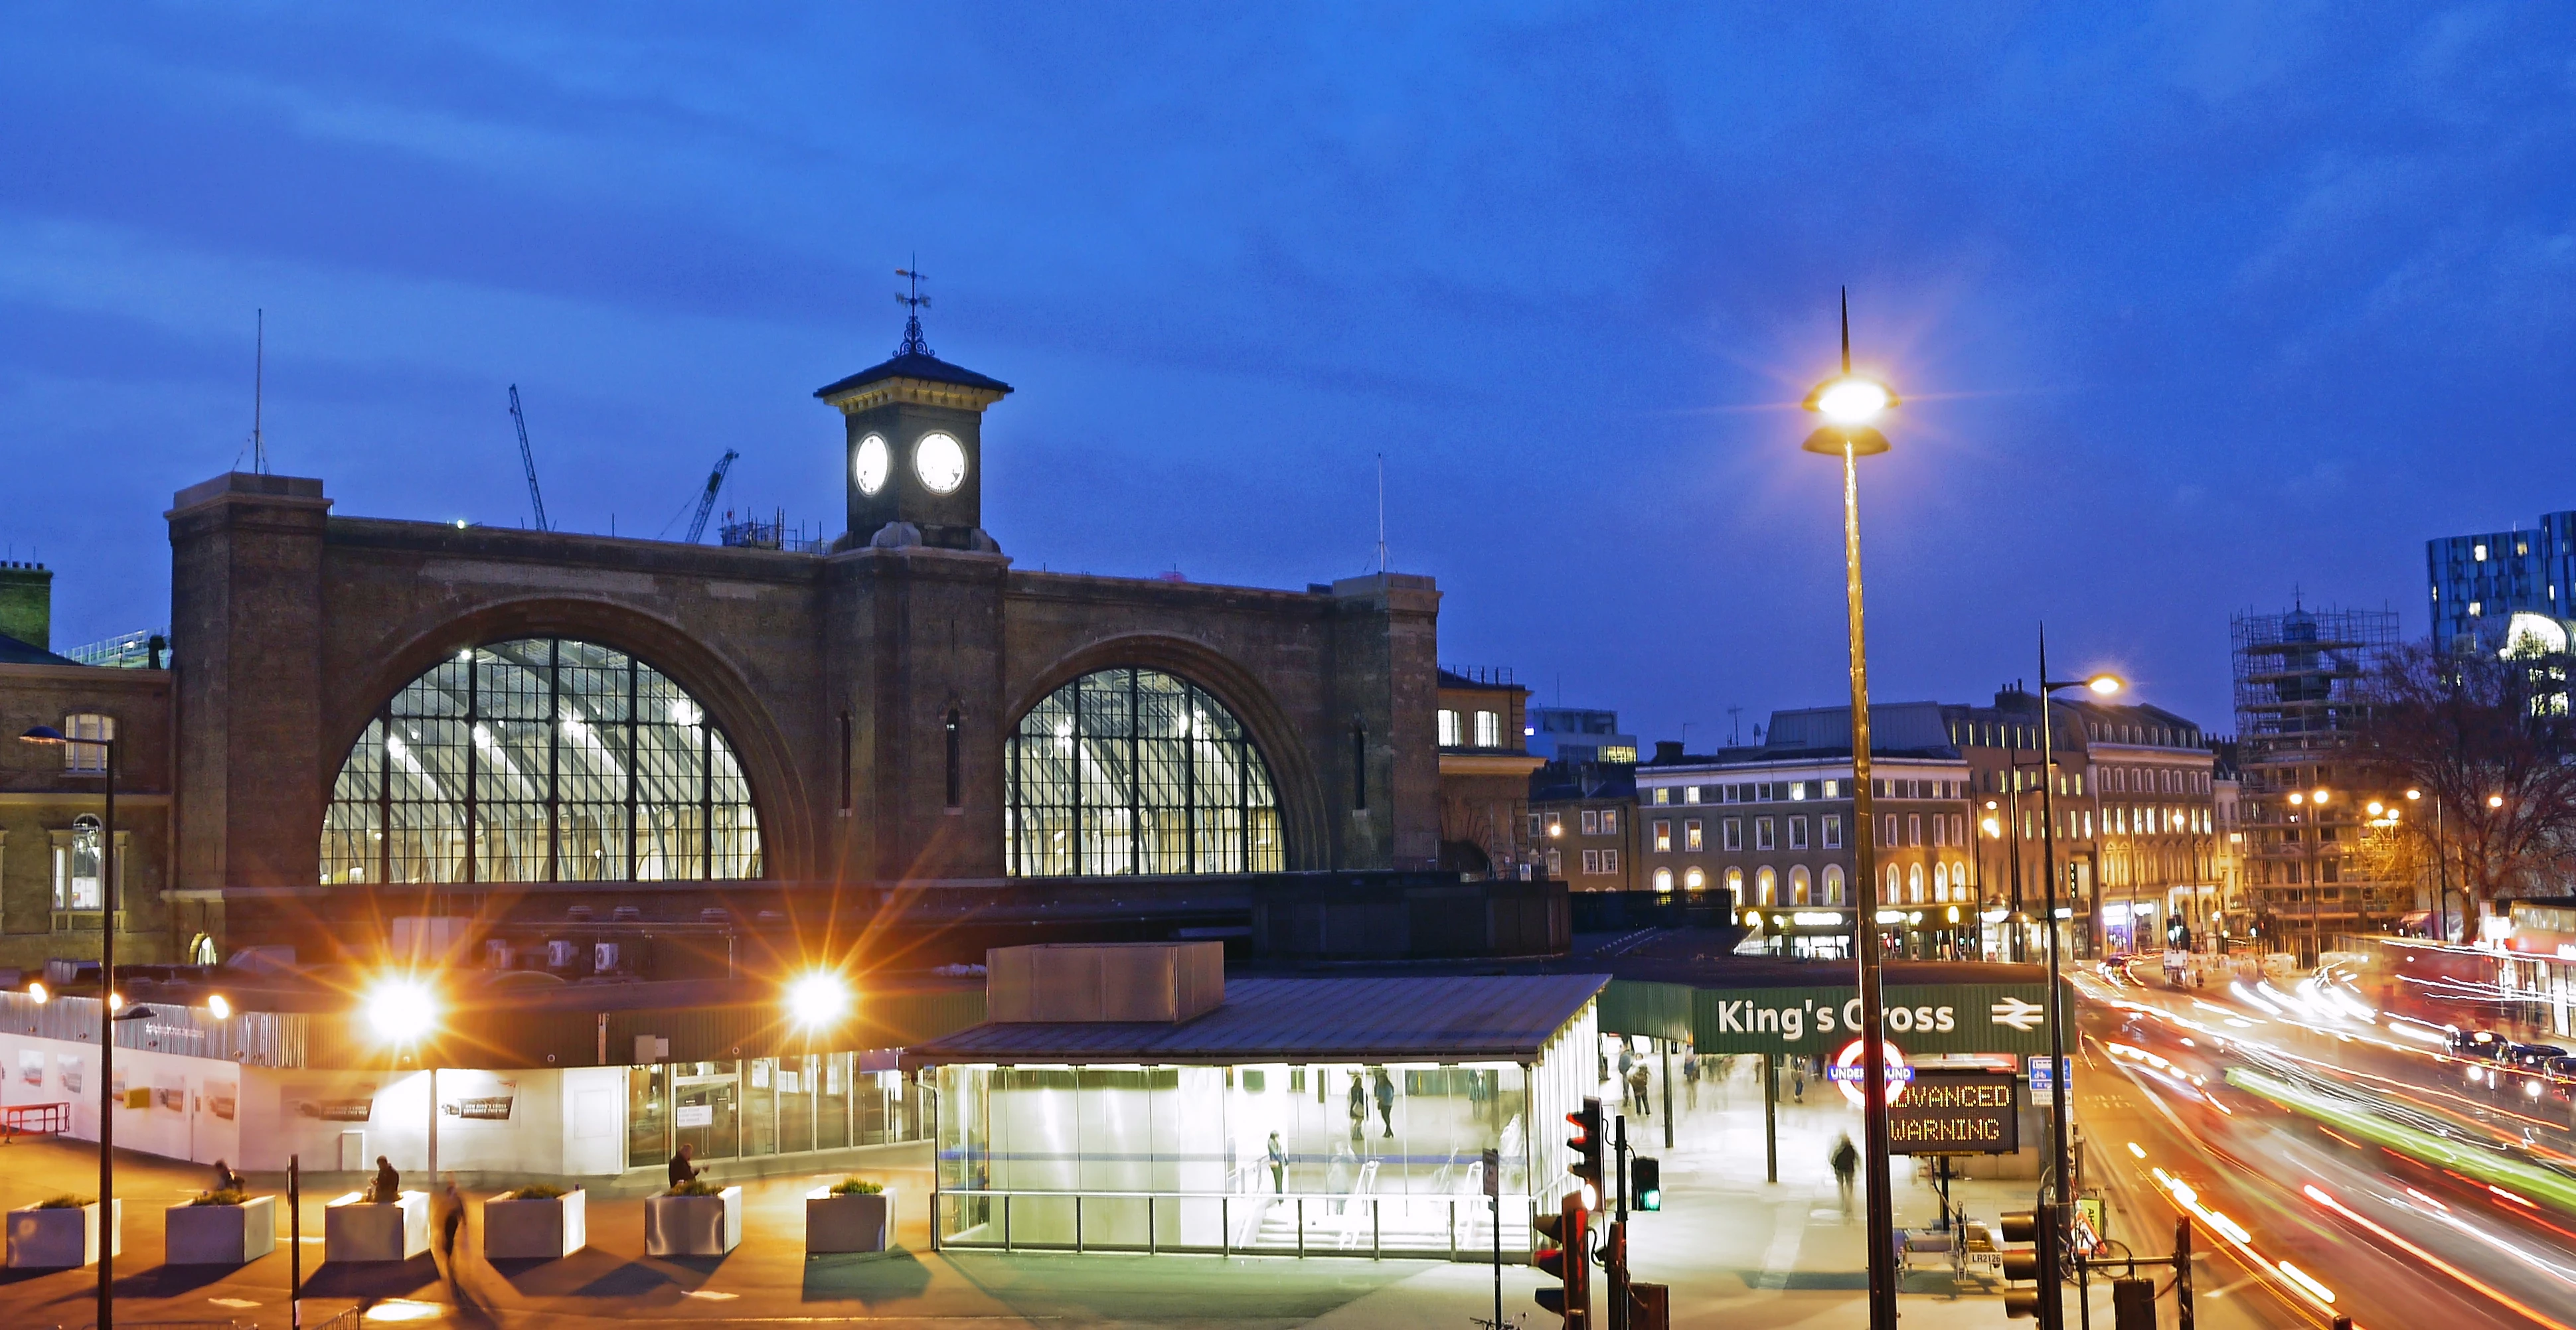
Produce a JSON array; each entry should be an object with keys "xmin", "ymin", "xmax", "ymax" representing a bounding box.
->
[{"xmin": 1803, "ymin": 291, "xmax": 1896, "ymax": 1330}]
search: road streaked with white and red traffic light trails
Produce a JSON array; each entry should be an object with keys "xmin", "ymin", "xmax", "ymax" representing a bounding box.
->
[{"xmin": 2073, "ymin": 966, "xmax": 2576, "ymax": 1330}]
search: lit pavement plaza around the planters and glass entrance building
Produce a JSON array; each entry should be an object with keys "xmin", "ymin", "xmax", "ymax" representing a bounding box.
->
[{"xmin": 0, "ymin": 1059, "xmax": 2228, "ymax": 1330}]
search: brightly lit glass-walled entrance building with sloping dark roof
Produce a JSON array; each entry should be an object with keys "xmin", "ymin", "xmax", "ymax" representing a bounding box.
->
[{"xmin": 904, "ymin": 974, "xmax": 1607, "ymax": 1260}]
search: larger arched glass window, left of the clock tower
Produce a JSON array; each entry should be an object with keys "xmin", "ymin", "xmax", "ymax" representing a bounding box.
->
[{"xmin": 322, "ymin": 636, "xmax": 760, "ymax": 884}]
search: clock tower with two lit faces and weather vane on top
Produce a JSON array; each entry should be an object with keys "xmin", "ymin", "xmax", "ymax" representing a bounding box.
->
[{"xmin": 814, "ymin": 271, "xmax": 1010, "ymax": 549}]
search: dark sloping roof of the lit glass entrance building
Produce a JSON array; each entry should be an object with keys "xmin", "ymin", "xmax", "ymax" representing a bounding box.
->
[{"xmin": 904, "ymin": 974, "xmax": 1610, "ymax": 1070}]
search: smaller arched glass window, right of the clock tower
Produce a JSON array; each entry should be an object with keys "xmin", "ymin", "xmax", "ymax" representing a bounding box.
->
[{"xmin": 1002, "ymin": 670, "xmax": 1288, "ymax": 876}]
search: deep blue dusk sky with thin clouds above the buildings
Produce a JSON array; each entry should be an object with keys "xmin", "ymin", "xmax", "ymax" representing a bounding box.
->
[{"xmin": 0, "ymin": 3, "xmax": 2576, "ymax": 747}]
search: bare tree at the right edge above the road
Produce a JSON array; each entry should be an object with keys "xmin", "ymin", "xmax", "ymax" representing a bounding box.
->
[{"xmin": 2360, "ymin": 642, "xmax": 2576, "ymax": 905}]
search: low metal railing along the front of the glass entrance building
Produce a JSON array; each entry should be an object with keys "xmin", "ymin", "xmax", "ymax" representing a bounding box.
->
[{"xmin": 930, "ymin": 1188, "xmax": 1530, "ymax": 1260}]
